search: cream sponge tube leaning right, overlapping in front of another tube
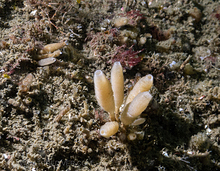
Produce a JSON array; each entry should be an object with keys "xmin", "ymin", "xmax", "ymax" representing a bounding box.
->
[{"xmin": 121, "ymin": 91, "xmax": 152, "ymax": 125}]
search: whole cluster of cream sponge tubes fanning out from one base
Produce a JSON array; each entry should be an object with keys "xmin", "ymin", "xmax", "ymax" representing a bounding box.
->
[{"xmin": 94, "ymin": 62, "xmax": 153, "ymax": 138}]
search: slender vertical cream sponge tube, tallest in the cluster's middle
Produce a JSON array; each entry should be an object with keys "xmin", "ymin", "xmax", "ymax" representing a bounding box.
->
[{"xmin": 111, "ymin": 62, "xmax": 124, "ymax": 119}]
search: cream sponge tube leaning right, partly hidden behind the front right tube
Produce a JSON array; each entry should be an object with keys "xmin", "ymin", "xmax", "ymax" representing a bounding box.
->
[{"xmin": 125, "ymin": 74, "xmax": 153, "ymax": 104}]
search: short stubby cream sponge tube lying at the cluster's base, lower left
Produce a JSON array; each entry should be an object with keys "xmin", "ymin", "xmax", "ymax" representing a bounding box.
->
[{"xmin": 100, "ymin": 121, "xmax": 119, "ymax": 138}]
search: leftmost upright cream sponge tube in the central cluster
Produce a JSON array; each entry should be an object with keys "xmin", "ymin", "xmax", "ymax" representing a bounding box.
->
[{"xmin": 94, "ymin": 70, "xmax": 115, "ymax": 121}]
